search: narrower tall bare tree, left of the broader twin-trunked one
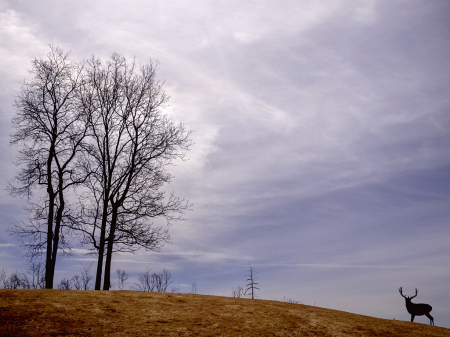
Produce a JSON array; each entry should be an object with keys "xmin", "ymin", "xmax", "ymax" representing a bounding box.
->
[{"xmin": 9, "ymin": 47, "xmax": 87, "ymax": 288}]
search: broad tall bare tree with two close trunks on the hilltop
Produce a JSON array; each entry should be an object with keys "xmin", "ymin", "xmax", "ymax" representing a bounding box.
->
[{"xmin": 77, "ymin": 54, "xmax": 191, "ymax": 290}]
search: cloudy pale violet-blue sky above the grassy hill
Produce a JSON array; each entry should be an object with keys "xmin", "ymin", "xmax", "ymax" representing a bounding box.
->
[{"xmin": 0, "ymin": 0, "xmax": 450, "ymax": 328}]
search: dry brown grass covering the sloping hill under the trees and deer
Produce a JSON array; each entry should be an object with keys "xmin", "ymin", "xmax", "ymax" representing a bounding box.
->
[{"xmin": 0, "ymin": 290, "xmax": 450, "ymax": 336}]
